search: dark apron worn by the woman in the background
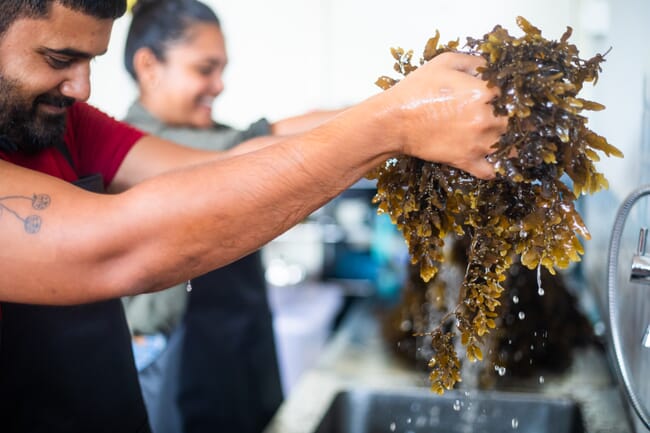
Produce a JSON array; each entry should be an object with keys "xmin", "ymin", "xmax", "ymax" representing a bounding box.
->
[{"xmin": 178, "ymin": 252, "xmax": 283, "ymax": 433}]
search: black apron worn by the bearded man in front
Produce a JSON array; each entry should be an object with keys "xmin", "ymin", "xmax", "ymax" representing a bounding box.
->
[{"xmin": 0, "ymin": 144, "xmax": 151, "ymax": 433}]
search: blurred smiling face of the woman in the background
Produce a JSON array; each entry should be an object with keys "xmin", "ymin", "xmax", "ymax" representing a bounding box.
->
[{"xmin": 139, "ymin": 23, "xmax": 228, "ymax": 128}]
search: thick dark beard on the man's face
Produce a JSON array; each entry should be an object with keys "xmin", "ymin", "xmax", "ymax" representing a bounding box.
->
[{"xmin": 0, "ymin": 75, "xmax": 74, "ymax": 155}]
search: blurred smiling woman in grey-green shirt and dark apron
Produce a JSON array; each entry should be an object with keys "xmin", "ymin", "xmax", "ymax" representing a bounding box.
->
[{"xmin": 124, "ymin": 0, "xmax": 282, "ymax": 433}]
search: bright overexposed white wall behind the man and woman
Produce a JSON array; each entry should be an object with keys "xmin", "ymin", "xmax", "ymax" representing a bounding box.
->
[{"xmin": 91, "ymin": 0, "xmax": 579, "ymax": 126}]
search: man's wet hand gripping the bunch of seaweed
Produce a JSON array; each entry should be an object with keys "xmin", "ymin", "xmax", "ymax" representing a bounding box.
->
[{"xmin": 380, "ymin": 53, "xmax": 508, "ymax": 178}]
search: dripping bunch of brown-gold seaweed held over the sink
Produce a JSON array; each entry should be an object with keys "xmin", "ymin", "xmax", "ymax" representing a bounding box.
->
[{"xmin": 367, "ymin": 17, "xmax": 623, "ymax": 394}]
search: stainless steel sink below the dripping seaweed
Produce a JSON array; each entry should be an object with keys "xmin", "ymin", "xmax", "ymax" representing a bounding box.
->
[{"xmin": 314, "ymin": 389, "xmax": 585, "ymax": 433}]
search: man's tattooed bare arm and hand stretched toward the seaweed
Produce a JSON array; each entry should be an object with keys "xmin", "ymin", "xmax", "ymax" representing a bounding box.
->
[{"xmin": 0, "ymin": 54, "xmax": 506, "ymax": 304}]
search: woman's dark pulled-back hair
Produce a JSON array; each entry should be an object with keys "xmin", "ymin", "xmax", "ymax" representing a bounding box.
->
[{"xmin": 124, "ymin": 0, "xmax": 221, "ymax": 81}]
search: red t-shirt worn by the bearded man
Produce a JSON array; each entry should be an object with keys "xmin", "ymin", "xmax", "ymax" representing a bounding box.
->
[{"xmin": 0, "ymin": 102, "xmax": 144, "ymax": 186}]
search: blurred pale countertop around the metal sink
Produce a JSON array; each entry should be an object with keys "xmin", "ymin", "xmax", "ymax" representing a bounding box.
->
[{"xmin": 264, "ymin": 302, "xmax": 633, "ymax": 433}]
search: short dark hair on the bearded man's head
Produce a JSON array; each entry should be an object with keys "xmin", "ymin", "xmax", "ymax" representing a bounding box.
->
[{"xmin": 0, "ymin": 0, "xmax": 126, "ymax": 37}]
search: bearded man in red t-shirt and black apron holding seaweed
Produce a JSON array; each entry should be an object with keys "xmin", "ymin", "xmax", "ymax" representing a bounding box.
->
[{"xmin": 0, "ymin": 0, "xmax": 506, "ymax": 433}]
